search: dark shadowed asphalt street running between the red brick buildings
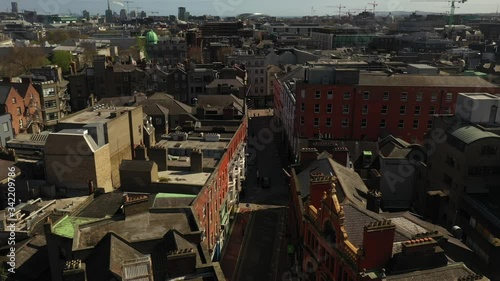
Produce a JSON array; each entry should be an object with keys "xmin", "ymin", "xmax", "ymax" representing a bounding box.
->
[{"xmin": 233, "ymin": 114, "xmax": 289, "ymax": 281}]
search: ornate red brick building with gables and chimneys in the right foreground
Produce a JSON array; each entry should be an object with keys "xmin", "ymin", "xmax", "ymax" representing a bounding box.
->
[{"xmin": 290, "ymin": 149, "xmax": 481, "ymax": 281}]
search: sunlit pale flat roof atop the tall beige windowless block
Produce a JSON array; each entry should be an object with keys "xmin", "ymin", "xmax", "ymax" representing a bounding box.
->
[{"xmin": 59, "ymin": 106, "xmax": 135, "ymax": 124}]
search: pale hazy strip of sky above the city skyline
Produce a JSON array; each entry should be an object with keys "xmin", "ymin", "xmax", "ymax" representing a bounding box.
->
[{"xmin": 0, "ymin": 0, "xmax": 500, "ymax": 17}]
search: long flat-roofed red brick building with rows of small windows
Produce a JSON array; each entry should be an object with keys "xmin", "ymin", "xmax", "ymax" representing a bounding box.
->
[{"xmin": 292, "ymin": 67, "xmax": 500, "ymax": 142}]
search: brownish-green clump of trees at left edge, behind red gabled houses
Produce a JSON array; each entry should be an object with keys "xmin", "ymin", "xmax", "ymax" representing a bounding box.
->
[{"xmin": 0, "ymin": 47, "xmax": 50, "ymax": 77}]
